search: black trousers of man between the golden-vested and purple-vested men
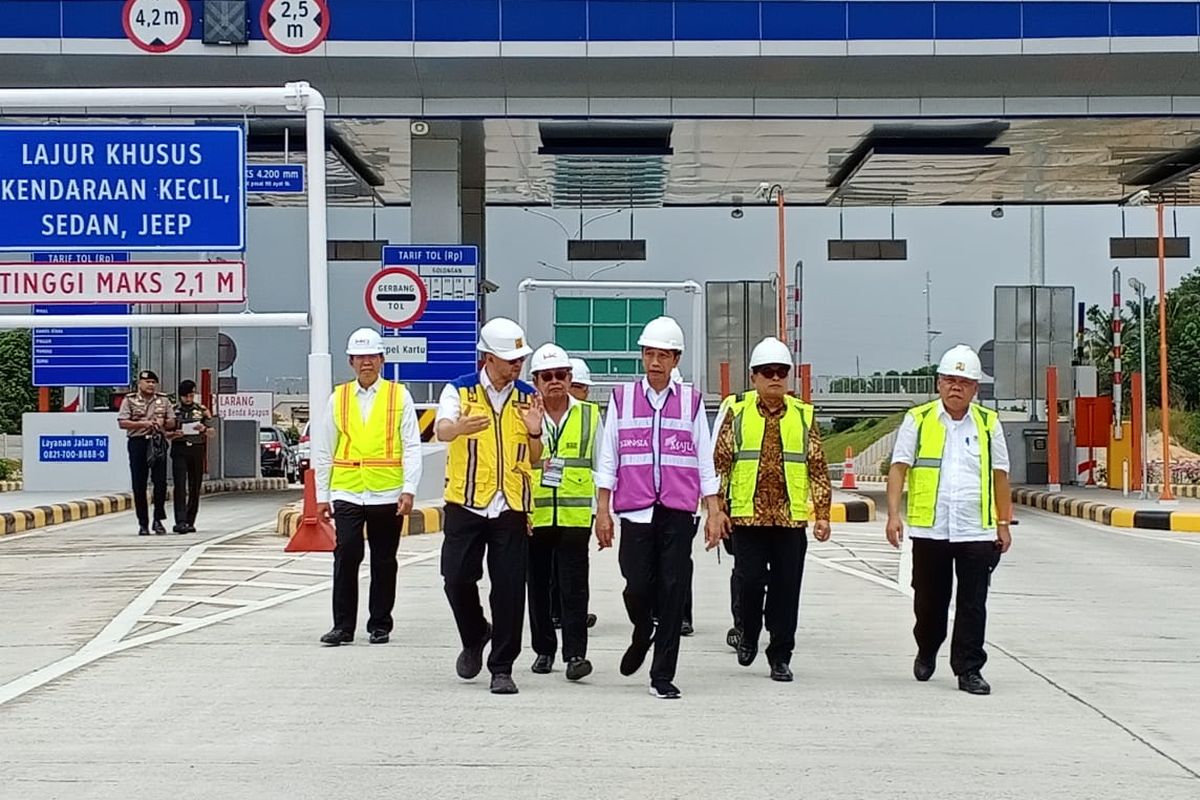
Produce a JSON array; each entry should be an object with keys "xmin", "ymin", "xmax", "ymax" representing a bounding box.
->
[{"xmin": 529, "ymin": 525, "xmax": 592, "ymax": 661}]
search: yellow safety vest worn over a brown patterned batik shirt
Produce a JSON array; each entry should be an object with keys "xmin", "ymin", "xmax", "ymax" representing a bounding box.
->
[{"xmin": 730, "ymin": 392, "xmax": 814, "ymax": 522}]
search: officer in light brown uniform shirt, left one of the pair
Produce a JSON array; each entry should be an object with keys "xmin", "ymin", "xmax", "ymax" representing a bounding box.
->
[{"xmin": 116, "ymin": 369, "xmax": 175, "ymax": 536}]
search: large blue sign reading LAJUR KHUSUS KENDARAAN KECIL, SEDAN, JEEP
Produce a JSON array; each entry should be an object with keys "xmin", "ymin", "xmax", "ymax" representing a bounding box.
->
[{"xmin": 0, "ymin": 125, "xmax": 246, "ymax": 251}]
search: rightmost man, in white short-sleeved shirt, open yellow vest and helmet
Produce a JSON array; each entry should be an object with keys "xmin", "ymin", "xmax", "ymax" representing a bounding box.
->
[{"xmin": 887, "ymin": 344, "xmax": 1013, "ymax": 694}]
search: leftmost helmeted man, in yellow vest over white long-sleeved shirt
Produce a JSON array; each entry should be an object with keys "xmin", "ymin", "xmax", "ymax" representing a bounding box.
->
[{"xmin": 312, "ymin": 327, "xmax": 421, "ymax": 646}]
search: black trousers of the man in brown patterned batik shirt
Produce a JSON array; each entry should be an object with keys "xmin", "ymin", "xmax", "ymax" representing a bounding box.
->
[{"xmin": 733, "ymin": 525, "xmax": 809, "ymax": 664}]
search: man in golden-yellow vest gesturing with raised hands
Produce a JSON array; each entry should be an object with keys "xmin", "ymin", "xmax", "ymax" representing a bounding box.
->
[{"xmin": 436, "ymin": 317, "xmax": 542, "ymax": 694}]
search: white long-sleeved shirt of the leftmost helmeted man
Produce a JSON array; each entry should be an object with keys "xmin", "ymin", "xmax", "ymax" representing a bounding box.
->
[{"xmin": 312, "ymin": 380, "xmax": 421, "ymax": 505}]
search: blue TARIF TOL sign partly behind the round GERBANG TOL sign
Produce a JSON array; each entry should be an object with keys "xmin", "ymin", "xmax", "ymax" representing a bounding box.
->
[{"xmin": 383, "ymin": 245, "xmax": 479, "ymax": 383}]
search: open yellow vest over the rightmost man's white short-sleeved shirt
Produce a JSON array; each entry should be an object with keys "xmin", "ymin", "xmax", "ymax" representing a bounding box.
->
[{"xmin": 908, "ymin": 401, "xmax": 996, "ymax": 529}]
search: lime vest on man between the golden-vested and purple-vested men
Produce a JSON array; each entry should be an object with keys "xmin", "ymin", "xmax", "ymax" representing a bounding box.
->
[{"xmin": 533, "ymin": 402, "xmax": 600, "ymax": 528}]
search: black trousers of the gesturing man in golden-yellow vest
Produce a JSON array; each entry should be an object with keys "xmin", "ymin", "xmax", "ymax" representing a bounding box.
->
[{"xmin": 442, "ymin": 503, "xmax": 529, "ymax": 675}]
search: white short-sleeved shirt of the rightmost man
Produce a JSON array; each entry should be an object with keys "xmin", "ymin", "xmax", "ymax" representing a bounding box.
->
[{"xmin": 892, "ymin": 401, "xmax": 1009, "ymax": 542}]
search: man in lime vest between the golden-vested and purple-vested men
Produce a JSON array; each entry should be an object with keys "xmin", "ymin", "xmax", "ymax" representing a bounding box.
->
[{"xmin": 529, "ymin": 344, "xmax": 600, "ymax": 680}]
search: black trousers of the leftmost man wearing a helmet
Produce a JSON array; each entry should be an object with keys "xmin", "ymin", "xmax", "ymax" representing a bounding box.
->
[{"xmin": 334, "ymin": 500, "xmax": 403, "ymax": 633}]
